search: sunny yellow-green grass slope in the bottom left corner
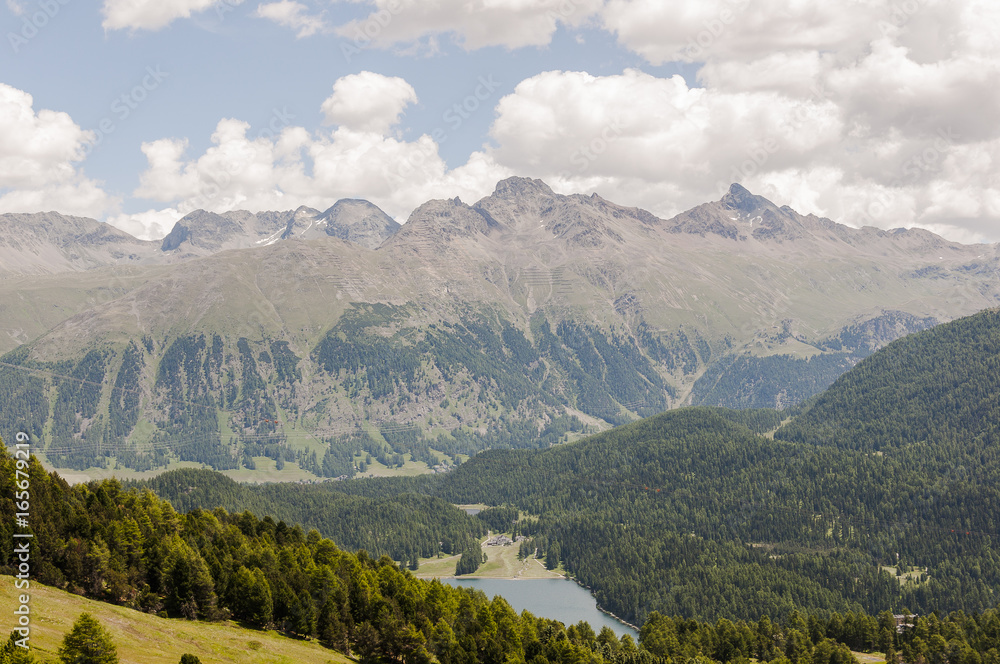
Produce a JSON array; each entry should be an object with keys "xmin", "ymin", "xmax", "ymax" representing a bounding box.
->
[{"xmin": 0, "ymin": 576, "xmax": 352, "ymax": 664}]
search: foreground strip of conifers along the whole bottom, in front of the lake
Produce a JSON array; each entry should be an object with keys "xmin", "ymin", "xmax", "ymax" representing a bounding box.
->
[{"xmin": 9, "ymin": 444, "xmax": 1000, "ymax": 664}]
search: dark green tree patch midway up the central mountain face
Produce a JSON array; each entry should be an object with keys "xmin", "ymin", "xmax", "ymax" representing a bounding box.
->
[{"xmin": 313, "ymin": 304, "xmax": 674, "ymax": 444}]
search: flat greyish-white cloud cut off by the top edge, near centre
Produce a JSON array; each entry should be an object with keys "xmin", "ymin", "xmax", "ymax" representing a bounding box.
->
[{"xmin": 336, "ymin": 0, "xmax": 603, "ymax": 50}]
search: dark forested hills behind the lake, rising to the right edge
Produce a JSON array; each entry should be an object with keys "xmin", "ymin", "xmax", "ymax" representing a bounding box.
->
[{"xmin": 143, "ymin": 311, "xmax": 1000, "ymax": 622}]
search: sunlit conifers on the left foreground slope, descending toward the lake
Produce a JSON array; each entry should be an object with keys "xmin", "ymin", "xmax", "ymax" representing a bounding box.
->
[{"xmin": 0, "ymin": 452, "xmax": 617, "ymax": 664}]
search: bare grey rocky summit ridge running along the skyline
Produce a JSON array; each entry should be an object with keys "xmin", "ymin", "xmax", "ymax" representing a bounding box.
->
[{"xmin": 0, "ymin": 177, "xmax": 998, "ymax": 274}]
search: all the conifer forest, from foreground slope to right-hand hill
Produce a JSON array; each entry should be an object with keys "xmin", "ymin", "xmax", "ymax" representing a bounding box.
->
[{"xmin": 0, "ymin": 311, "xmax": 1000, "ymax": 664}]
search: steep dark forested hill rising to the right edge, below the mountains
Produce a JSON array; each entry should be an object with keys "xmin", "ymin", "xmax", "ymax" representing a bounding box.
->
[{"xmin": 776, "ymin": 309, "xmax": 1000, "ymax": 456}]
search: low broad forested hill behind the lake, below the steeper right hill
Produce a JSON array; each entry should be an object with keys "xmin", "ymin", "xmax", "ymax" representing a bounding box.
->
[{"xmin": 427, "ymin": 402, "xmax": 1000, "ymax": 620}]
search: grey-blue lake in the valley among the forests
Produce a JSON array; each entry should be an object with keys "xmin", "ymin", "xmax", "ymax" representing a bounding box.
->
[{"xmin": 441, "ymin": 579, "xmax": 639, "ymax": 640}]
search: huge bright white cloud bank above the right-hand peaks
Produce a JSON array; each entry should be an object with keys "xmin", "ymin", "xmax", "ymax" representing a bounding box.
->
[{"xmin": 480, "ymin": 59, "xmax": 1000, "ymax": 240}]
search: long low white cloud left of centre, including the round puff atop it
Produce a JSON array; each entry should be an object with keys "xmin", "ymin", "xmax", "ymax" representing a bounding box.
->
[{"xmin": 129, "ymin": 72, "xmax": 511, "ymax": 228}]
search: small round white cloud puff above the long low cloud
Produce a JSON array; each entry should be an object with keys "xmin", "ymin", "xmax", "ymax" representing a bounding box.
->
[{"xmin": 322, "ymin": 71, "xmax": 417, "ymax": 134}]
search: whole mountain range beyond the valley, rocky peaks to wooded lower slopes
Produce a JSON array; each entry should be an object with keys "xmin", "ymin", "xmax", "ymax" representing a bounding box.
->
[{"xmin": 0, "ymin": 178, "xmax": 1000, "ymax": 475}]
